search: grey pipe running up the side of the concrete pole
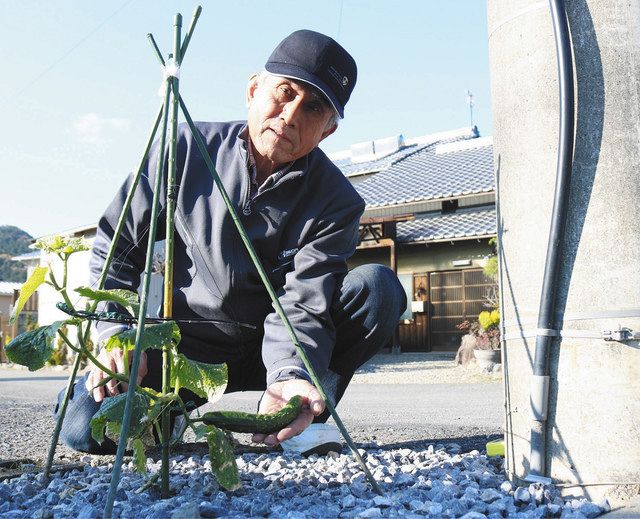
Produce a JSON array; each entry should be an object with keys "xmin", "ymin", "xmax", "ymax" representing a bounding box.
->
[{"xmin": 525, "ymin": 0, "xmax": 575, "ymax": 482}]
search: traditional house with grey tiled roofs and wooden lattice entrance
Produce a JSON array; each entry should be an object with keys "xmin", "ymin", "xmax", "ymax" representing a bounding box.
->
[{"xmin": 331, "ymin": 127, "xmax": 496, "ymax": 351}]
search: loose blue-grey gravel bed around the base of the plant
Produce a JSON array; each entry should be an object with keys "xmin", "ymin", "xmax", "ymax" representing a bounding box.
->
[{"xmin": 0, "ymin": 444, "xmax": 609, "ymax": 519}]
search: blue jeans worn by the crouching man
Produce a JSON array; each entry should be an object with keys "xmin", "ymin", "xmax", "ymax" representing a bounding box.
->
[{"xmin": 55, "ymin": 264, "xmax": 407, "ymax": 454}]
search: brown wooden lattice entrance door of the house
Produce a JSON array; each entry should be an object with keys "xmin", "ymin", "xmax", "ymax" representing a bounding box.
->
[{"xmin": 400, "ymin": 269, "xmax": 496, "ymax": 351}]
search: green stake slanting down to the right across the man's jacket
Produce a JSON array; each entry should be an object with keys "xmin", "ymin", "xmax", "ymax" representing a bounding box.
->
[{"xmin": 180, "ymin": 98, "xmax": 382, "ymax": 495}]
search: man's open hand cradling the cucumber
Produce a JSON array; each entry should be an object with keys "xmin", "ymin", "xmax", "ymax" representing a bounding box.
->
[{"xmin": 251, "ymin": 379, "xmax": 324, "ymax": 447}]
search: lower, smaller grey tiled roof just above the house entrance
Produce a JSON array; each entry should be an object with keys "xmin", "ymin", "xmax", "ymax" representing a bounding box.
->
[{"xmin": 397, "ymin": 206, "xmax": 496, "ymax": 243}]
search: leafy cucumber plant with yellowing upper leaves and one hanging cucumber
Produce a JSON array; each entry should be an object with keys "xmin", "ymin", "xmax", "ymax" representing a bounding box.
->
[{"xmin": 6, "ymin": 236, "xmax": 301, "ymax": 490}]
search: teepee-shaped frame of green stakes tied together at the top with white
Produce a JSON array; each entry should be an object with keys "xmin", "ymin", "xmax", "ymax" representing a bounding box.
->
[{"xmin": 48, "ymin": 6, "xmax": 382, "ymax": 518}]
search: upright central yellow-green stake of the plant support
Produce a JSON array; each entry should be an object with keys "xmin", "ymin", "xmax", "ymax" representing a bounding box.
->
[{"xmin": 160, "ymin": 13, "xmax": 182, "ymax": 499}]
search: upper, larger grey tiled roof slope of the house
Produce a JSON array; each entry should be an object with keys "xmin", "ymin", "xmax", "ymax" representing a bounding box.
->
[{"xmin": 355, "ymin": 139, "xmax": 494, "ymax": 209}]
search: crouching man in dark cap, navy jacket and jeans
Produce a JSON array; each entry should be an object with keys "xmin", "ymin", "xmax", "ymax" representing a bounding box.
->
[{"xmin": 61, "ymin": 30, "xmax": 406, "ymax": 458}]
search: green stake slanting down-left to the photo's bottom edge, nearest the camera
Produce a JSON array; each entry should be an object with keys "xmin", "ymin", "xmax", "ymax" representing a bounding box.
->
[{"xmin": 103, "ymin": 81, "xmax": 171, "ymax": 519}]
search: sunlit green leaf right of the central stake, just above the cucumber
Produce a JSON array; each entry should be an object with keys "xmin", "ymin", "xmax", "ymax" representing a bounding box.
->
[{"xmin": 171, "ymin": 353, "xmax": 228, "ymax": 402}]
